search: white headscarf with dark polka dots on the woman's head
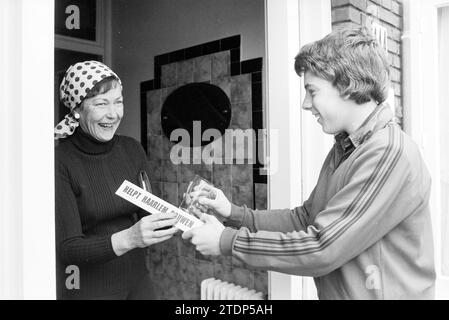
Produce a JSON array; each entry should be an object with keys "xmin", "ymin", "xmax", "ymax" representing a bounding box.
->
[{"xmin": 54, "ymin": 61, "xmax": 122, "ymax": 139}]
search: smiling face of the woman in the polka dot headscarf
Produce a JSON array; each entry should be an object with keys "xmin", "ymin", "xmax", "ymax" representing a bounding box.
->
[{"xmin": 78, "ymin": 85, "xmax": 123, "ymax": 142}]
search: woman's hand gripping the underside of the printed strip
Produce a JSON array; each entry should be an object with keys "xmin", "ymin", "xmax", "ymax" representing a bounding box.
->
[{"xmin": 111, "ymin": 213, "xmax": 179, "ymax": 256}]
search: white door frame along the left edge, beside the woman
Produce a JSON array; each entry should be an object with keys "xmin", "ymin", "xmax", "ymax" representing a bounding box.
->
[{"xmin": 0, "ymin": 0, "xmax": 56, "ymax": 300}]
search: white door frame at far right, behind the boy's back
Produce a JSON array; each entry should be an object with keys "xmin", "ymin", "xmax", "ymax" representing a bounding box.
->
[{"xmin": 402, "ymin": 0, "xmax": 449, "ymax": 299}]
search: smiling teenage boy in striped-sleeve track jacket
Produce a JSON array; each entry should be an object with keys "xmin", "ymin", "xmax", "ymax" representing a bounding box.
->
[{"xmin": 183, "ymin": 28, "xmax": 435, "ymax": 299}]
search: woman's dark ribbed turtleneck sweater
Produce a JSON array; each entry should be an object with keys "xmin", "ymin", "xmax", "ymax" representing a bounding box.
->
[{"xmin": 55, "ymin": 128, "xmax": 148, "ymax": 299}]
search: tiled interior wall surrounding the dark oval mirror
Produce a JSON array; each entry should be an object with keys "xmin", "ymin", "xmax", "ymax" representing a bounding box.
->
[{"xmin": 144, "ymin": 47, "xmax": 268, "ymax": 300}]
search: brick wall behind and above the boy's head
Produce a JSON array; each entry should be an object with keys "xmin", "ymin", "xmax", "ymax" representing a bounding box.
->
[{"xmin": 332, "ymin": 0, "xmax": 403, "ymax": 124}]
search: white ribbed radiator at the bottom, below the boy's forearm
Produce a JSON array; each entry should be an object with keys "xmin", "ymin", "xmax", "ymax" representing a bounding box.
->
[{"xmin": 201, "ymin": 278, "xmax": 264, "ymax": 300}]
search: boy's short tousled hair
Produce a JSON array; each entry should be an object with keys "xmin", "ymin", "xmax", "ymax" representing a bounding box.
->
[{"xmin": 295, "ymin": 26, "xmax": 390, "ymax": 104}]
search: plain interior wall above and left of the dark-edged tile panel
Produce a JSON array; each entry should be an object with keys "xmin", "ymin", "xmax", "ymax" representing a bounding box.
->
[{"xmin": 111, "ymin": 0, "xmax": 265, "ymax": 141}]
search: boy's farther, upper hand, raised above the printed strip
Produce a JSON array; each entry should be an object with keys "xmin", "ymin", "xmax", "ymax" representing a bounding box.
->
[{"xmin": 189, "ymin": 186, "xmax": 231, "ymax": 218}]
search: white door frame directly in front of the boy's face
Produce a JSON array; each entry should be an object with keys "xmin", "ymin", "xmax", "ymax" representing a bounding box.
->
[{"xmin": 265, "ymin": 0, "xmax": 332, "ymax": 300}]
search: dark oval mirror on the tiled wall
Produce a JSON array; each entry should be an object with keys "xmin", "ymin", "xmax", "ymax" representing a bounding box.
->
[{"xmin": 161, "ymin": 83, "xmax": 231, "ymax": 147}]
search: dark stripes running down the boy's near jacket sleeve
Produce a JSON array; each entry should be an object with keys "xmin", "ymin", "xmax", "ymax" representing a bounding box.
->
[{"xmin": 234, "ymin": 126, "xmax": 403, "ymax": 255}]
